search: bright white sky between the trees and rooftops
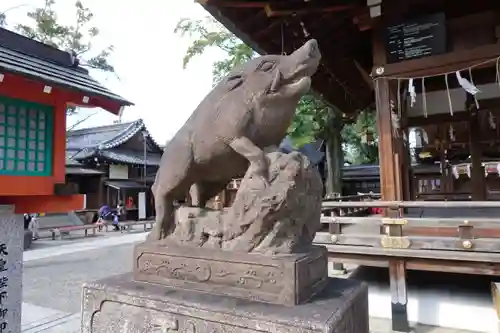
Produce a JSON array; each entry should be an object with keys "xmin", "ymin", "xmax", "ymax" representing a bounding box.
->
[{"xmin": 0, "ymin": 0, "xmax": 222, "ymax": 144}]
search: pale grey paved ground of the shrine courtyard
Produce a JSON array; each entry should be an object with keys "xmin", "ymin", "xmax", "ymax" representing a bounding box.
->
[{"xmin": 23, "ymin": 233, "xmax": 478, "ymax": 333}]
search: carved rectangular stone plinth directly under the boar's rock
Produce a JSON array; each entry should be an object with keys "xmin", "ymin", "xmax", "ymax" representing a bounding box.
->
[{"xmin": 133, "ymin": 243, "xmax": 328, "ymax": 306}]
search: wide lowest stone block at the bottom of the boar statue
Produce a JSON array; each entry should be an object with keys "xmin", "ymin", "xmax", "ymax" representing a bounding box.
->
[{"xmin": 81, "ymin": 275, "xmax": 369, "ymax": 333}]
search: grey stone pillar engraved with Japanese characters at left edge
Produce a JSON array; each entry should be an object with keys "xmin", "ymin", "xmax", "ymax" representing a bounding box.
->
[{"xmin": 0, "ymin": 206, "xmax": 24, "ymax": 333}]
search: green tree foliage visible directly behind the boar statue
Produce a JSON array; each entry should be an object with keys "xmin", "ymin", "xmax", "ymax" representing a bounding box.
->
[{"xmin": 174, "ymin": 16, "xmax": 378, "ymax": 164}]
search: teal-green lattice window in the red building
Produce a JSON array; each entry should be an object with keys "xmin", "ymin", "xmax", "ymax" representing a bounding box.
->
[{"xmin": 0, "ymin": 96, "xmax": 54, "ymax": 176}]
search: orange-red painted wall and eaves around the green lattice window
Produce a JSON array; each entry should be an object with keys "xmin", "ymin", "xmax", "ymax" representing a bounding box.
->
[{"xmin": 0, "ymin": 73, "xmax": 120, "ymax": 212}]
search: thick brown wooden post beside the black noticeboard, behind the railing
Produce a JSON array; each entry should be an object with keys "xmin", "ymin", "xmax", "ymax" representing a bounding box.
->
[{"xmin": 373, "ymin": 21, "xmax": 410, "ymax": 332}]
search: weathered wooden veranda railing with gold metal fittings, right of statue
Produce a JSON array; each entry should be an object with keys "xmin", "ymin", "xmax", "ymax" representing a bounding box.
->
[{"xmin": 315, "ymin": 200, "xmax": 500, "ymax": 261}]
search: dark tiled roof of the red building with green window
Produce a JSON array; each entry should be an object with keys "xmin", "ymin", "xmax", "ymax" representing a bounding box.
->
[{"xmin": 0, "ymin": 28, "xmax": 133, "ymax": 105}]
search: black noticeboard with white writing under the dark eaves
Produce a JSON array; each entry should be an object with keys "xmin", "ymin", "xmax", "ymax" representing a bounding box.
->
[{"xmin": 386, "ymin": 13, "xmax": 446, "ymax": 63}]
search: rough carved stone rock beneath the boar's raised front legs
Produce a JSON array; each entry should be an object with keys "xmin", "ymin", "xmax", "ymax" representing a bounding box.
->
[{"xmin": 160, "ymin": 152, "xmax": 323, "ymax": 254}]
